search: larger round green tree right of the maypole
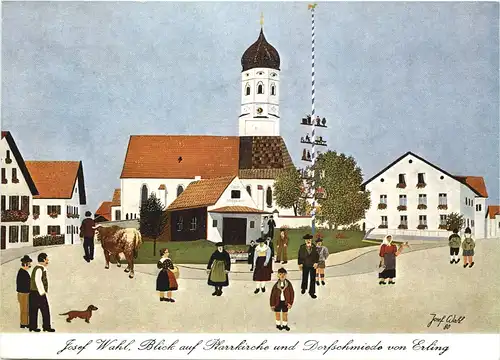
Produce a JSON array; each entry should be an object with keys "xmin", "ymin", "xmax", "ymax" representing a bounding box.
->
[{"xmin": 309, "ymin": 151, "xmax": 370, "ymax": 229}]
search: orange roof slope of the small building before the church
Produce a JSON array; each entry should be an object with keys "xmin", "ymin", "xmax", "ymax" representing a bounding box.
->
[{"xmin": 167, "ymin": 176, "xmax": 235, "ymax": 211}]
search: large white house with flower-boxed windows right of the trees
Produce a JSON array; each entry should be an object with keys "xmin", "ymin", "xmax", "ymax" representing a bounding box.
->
[{"xmin": 363, "ymin": 152, "xmax": 488, "ymax": 238}]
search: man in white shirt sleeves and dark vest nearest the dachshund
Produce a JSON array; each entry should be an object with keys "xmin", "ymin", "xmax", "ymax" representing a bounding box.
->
[{"xmin": 29, "ymin": 253, "xmax": 55, "ymax": 332}]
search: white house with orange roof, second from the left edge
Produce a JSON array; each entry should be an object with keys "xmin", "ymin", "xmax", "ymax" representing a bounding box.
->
[{"xmin": 26, "ymin": 161, "xmax": 86, "ymax": 244}]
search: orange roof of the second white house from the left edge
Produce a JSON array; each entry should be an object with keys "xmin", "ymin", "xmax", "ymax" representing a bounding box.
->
[{"xmin": 25, "ymin": 161, "xmax": 80, "ymax": 199}]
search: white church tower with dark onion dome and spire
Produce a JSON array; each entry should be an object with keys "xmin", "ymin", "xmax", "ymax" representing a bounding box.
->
[{"xmin": 239, "ymin": 17, "xmax": 280, "ymax": 136}]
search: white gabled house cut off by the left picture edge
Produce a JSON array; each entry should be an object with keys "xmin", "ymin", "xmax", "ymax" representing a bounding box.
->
[{"xmin": 0, "ymin": 131, "xmax": 38, "ymax": 250}]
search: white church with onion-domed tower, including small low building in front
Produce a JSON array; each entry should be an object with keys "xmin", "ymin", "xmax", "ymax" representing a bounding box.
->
[{"xmin": 111, "ymin": 24, "xmax": 295, "ymax": 244}]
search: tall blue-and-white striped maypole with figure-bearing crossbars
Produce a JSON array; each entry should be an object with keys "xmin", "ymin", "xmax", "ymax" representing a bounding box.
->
[{"xmin": 301, "ymin": 4, "xmax": 326, "ymax": 235}]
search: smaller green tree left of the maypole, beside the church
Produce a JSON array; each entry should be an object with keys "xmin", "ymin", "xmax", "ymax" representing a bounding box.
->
[{"xmin": 274, "ymin": 168, "xmax": 304, "ymax": 216}]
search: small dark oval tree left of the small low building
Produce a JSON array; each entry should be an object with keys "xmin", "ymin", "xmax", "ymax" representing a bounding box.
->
[{"xmin": 139, "ymin": 194, "xmax": 167, "ymax": 255}]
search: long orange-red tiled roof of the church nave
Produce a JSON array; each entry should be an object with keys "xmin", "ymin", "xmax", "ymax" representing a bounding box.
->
[{"xmin": 121, "ymin": 135, "xmax": 239, "ymax": 179}]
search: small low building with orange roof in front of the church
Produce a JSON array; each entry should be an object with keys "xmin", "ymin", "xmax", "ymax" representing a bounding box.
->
[{"xmin": 167, "ymin": 176, "xmax": 267, "ymax": 245}]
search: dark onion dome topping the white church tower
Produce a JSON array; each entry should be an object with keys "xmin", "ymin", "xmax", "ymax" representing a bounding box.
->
[{"xmin": 241, "ymin": 29, "xmax": 280, "ymax": 71}]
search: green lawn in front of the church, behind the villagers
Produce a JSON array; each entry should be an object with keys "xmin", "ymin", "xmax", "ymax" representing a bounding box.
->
[{"xmin": 135, "ymin": 228, "xmax": 374, "ymax": 264}]
